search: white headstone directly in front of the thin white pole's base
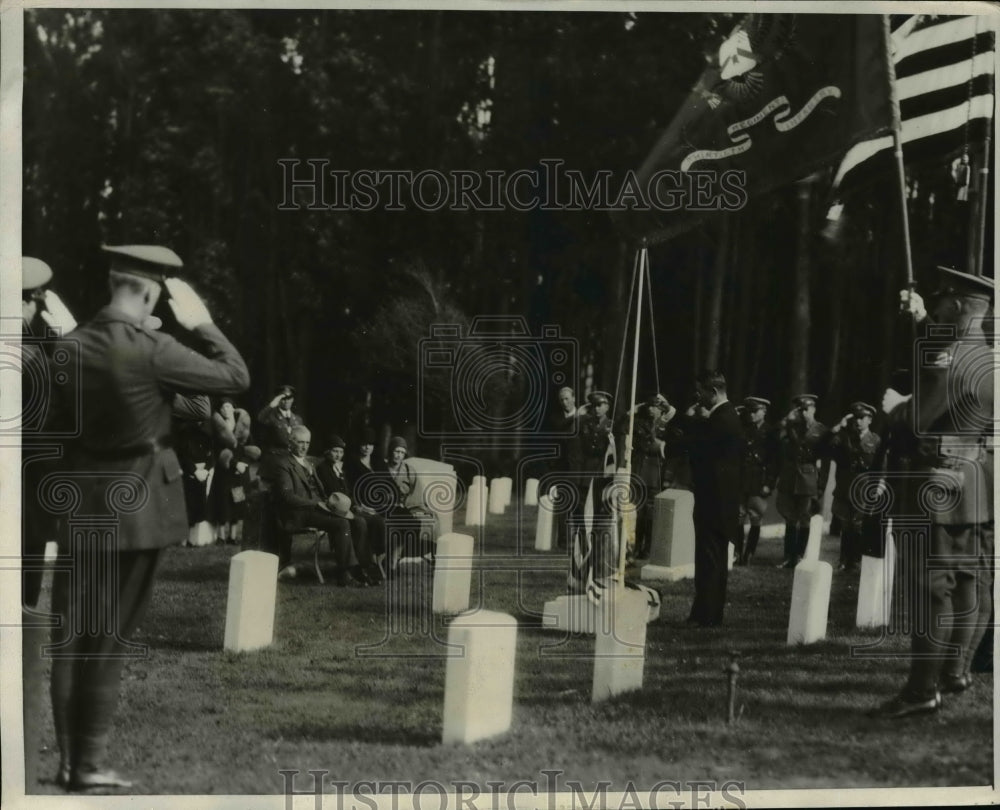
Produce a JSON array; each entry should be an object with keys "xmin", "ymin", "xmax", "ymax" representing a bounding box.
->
[{"xmin": 591, "ymin": 587, "xmax": 649, "ymax": 703}]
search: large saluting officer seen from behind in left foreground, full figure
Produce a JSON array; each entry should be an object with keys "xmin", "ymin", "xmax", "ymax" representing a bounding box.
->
[{"xmin": 51, "ymin": 245, "xmax": 250, "ymax": 790}]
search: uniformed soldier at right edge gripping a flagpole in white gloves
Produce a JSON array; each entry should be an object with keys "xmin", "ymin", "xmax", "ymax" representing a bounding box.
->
[{"xmin": 871, "ymin": 267, "xmax": 996, "ymax": 719}]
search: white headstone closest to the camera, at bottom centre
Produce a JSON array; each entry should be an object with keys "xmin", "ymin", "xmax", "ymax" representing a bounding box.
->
[{"xmin": 441, "ymin": 610, "xmax": 517, "ymax": 743}]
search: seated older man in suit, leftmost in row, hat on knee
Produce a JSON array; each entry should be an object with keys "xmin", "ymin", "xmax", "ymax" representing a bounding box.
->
[{"xmin": 267, "ymin": 425, "xmax": 374, "ymax": 586}]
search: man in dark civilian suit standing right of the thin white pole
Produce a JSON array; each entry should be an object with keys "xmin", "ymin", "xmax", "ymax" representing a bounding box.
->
[{"xmin": 667, "ymin": 371, "xmax": 744, "ymax": 627}]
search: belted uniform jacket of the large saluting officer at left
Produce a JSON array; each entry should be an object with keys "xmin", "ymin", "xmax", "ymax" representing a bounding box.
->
[{"xmin": 60, "ymin": 306, "xmax": 250, "ymax": 551}]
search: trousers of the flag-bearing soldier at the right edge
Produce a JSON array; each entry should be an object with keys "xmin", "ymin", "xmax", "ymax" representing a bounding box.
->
[{"xmin": 902, "ymin": 523, "xmax": 993, "ymax": 700}]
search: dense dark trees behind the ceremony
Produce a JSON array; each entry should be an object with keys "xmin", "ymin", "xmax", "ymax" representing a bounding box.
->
[{"xmin": 23, "ymin": 9, "xmax": 992, "ymax": 458}]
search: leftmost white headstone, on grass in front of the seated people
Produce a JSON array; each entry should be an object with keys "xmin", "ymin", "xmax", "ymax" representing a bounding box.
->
[{"xmin": 223, "ymin": 551, "xmax": 278, "ymax": 652}]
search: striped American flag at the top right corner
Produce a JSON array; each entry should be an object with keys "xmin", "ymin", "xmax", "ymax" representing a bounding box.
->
[{"xmin": 834, "ymin": 14, "xmax": 996, "ymax": 190}]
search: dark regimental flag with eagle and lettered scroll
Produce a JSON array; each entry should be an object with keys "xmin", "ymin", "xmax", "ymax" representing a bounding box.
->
[{"xmin": 616, "ymin": 14, "xmax": 891, "ymax": 242}]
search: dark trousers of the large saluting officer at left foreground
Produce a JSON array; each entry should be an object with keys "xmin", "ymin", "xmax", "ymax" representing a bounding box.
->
[{"xmin": 51, "ymin": 544, "xmax": 160, "ymax": 775}]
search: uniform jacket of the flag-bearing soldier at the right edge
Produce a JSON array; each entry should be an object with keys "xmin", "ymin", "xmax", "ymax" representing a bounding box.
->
[{"xmin": 888, "ymin": 334, "xmax": 996, "ymax": 525}]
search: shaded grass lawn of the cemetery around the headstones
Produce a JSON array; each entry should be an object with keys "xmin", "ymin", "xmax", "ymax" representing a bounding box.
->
[{"xmin": 30, "ymin": 504, "xmax": 993, "ymax": 792}]
